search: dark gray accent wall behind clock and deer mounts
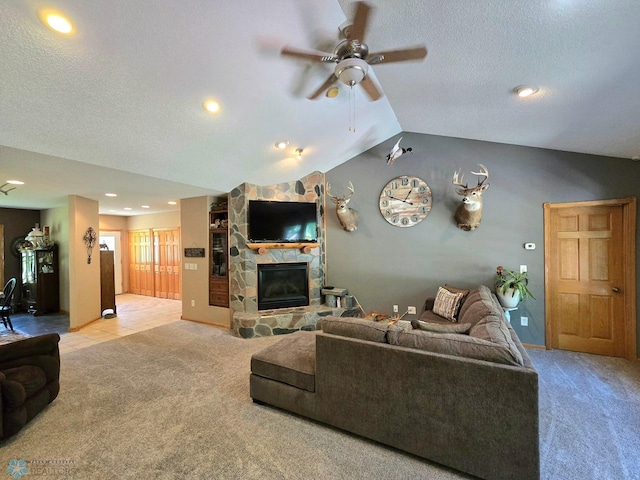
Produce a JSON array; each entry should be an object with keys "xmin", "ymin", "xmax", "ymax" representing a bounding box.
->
[{"xmin": 326, "ymin": 132, "xmax": 640, "ymax": 350}]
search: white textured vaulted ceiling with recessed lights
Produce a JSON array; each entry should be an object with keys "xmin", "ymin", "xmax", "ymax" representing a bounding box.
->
[{"xmin": 0, "ymin": 0, "xmax": 640, "ymax": 214}]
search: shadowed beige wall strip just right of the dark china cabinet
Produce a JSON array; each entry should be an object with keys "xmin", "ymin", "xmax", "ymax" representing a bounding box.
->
[{"xmin": 40, "ymin": 206, "xmax": 71, "ymax": 312}]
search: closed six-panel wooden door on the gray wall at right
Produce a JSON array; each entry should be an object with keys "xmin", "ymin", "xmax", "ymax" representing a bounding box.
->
[{"xmin": 545, "ymin": 197, "xmax": 635, "ymax": 357}]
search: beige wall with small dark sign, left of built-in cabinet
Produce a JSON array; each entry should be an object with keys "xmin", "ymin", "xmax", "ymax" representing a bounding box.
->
[{"xmin": 180, "ymin": 197, "xmax": 231, "ymax": 328}]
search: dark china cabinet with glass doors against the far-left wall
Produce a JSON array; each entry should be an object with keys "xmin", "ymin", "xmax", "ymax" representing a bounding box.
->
[{"xmin": 21, "ymin": 246, "xmax": 60, "ymax": 315}]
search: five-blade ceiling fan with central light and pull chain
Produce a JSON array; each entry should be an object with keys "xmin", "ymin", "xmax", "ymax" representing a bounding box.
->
[{"xmin": 281, "ymin": 2, "xmax": 427, "ymax": 101}]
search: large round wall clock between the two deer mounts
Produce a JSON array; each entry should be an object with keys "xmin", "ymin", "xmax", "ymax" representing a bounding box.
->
[{"xmin": 380, "ymin": 175, "xmax": 432, "ymax": 227}]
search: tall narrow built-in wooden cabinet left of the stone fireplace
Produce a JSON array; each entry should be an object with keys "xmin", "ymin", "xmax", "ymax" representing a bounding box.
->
[{"xmin": 209, "ymin": 199, "xmax": 229, "ymax": 307}]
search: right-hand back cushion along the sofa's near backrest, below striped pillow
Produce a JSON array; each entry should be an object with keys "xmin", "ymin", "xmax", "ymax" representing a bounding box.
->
[{"xmin": 389, "ymin": 330, "xmax": 521, "ymax": 365}]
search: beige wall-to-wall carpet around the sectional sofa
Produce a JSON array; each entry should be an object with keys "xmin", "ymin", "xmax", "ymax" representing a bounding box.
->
[{"xmin": 0, "ymin": 321, "xmax": 640, "ymax": 480}]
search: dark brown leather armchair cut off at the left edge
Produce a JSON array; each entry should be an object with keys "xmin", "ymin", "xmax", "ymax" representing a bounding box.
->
[{"xmin": 0, "ymin": 333, "xmax": 60, "ymax": 441}]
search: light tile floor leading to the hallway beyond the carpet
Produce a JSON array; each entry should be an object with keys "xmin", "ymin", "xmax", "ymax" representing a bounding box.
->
[{"xmin": 60, "ymin": 293, "xmax": 182, "ymax": 353}]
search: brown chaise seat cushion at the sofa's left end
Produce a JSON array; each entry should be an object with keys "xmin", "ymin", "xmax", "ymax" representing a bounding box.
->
[{"xmin": 251, "ymin": 330, "xmax": 316, "ymax": 392}]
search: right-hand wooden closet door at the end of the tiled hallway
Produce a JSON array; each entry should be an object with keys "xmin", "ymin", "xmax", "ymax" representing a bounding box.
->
[{"xmin": 153, "ymin": 229, "xmax": 182, "ymax": 300}]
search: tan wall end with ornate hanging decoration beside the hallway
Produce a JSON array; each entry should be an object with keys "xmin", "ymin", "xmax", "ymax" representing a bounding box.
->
[{"xmin": 68, "ymin": 195, "xmax": 101, "ymax": 330}]
